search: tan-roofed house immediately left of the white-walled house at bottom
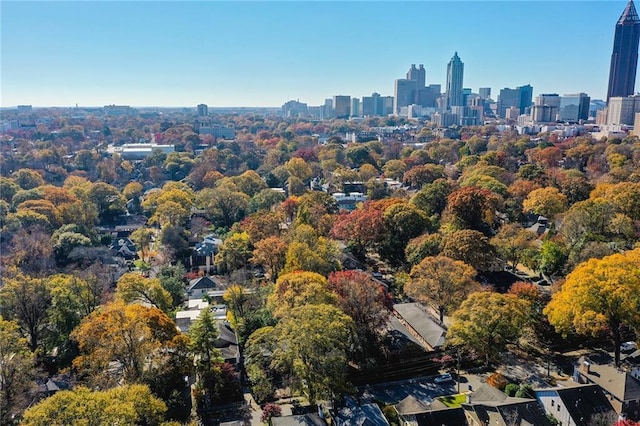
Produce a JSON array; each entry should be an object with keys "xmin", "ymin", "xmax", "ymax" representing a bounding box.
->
[{"xmin": 462, "ymin": 383, "xmax": 551, "ymax": 426}]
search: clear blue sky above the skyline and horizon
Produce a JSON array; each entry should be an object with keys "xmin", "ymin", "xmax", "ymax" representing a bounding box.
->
[{"xmin": 0, "ymin": 0, "xmax": 640, "ymax": 106}]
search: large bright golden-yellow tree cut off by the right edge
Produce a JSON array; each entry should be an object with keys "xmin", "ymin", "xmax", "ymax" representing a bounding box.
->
[{"xmin": 544, "ymin": 249, "xmax": 640, "ymax": 365}]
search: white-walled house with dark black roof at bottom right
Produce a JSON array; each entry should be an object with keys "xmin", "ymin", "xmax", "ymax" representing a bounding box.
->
[{"xmin": 535, "ymin": 385, "xmax": 618, "ymax": 426}]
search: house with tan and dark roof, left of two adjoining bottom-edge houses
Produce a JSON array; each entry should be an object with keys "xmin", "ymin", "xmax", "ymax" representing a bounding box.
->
[{"xmin": 394, "ymin": 395, "xmax": 467, "ymax": 426}]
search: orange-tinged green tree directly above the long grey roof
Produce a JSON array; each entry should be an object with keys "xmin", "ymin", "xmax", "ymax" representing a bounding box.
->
[{"xmin": 404, "ymin": 256, "xmax": 480, "ymax": 323}]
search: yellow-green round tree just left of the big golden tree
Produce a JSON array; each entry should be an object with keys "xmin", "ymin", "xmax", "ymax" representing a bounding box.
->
[{"xmin": 447, "ymin": 291, "xmax": 528, "ymax": 366}]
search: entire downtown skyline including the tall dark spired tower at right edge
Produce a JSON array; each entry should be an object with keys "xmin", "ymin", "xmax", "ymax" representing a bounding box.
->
[{"xmin": 282, "ymin": 0, "xmax": 640, "ymax": 135}]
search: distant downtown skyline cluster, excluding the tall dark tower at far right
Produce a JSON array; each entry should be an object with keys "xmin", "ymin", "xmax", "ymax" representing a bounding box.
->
[{"xmin": 282, "ymin": 52, "xmax": 590, "ymax": 127}]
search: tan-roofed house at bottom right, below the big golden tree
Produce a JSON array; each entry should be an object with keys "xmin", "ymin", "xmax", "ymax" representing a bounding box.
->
[{"xmin": 573, "ymin": 357, "xmax": 640, "ymax": 420}]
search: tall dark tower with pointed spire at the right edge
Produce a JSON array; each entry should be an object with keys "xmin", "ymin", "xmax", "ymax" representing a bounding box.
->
[{"xmin": 607, "ymin": 0, "xmax": 640, "ymax": 101}]
